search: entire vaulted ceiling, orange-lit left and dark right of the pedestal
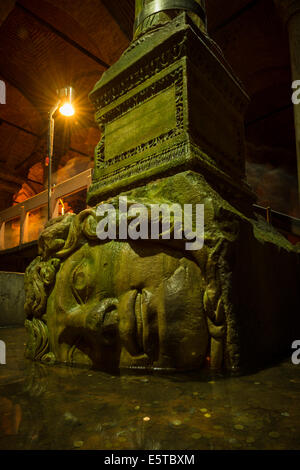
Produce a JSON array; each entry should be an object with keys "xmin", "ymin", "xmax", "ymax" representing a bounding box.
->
[{"xmin": 0, "ymin": 0, "xmax": 297, "ymax": 215}]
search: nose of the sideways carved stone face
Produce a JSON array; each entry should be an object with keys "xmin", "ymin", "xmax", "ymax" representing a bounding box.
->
[{"xmin": 86, "ymin": 298, "xmax": 119, "ymax": 344}]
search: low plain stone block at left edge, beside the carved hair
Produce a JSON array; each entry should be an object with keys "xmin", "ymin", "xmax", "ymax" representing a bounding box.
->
[{"xmin": 0, "ymin": 272, "xmax": 26, "ymax": 327}]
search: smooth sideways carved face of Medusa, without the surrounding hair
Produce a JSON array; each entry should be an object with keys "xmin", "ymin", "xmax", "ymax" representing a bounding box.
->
[{"xmin": 47, "ymin": 241, "xmax": 208, "ymax": 369}]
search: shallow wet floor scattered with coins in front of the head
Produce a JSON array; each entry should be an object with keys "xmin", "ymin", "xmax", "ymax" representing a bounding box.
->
[{"xmin": 0, "ymin": 328, "xmax": 300, "ymax": 450}]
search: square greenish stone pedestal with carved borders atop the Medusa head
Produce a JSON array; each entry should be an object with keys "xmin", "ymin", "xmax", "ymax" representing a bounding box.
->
[{"xmin": 88, "ymin": 13, "xmax": 254, "ymax": 215}]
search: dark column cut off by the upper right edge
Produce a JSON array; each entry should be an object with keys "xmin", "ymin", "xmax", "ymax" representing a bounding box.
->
[{"xmin": 275, "ymin": 0, "xmax": 300, "ymax": 201}]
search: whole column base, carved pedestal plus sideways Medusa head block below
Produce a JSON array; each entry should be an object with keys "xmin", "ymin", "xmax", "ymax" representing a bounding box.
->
[{"xmin": 25, "ymin": 2, "xmax": 300, "ymax": 372}]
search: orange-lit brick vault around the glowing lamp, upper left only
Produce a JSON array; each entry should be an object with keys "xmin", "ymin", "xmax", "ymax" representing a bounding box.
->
[{"xmin": 0, "ymin": 0, "xmax": 128, "ymax": 208}]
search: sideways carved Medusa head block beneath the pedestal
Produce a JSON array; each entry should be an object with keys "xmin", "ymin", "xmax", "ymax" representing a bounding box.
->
[{"xmin": 26, "ymin": 172, "xmax": 300, "ymax": 369}]
